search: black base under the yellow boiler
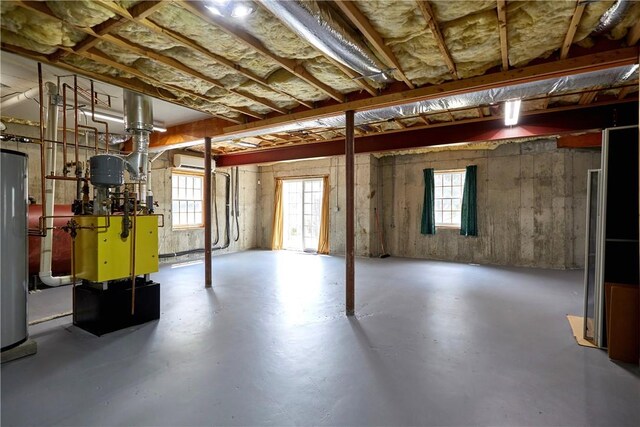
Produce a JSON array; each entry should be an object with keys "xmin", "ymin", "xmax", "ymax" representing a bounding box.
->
[{"xmin": 73, "ymin": 277, "xmax": 160, "ymax": 336}]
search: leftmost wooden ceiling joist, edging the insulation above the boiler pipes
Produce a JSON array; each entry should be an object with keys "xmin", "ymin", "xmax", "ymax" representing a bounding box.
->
[{"xmin": 1, "ymin": 43, "xmax": 242, "ymax": 124}]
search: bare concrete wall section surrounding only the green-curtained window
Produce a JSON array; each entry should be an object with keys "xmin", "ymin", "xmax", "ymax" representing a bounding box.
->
[{"xmin": 378, "ymin": 140, "xmax": 600, "ymax": 268}]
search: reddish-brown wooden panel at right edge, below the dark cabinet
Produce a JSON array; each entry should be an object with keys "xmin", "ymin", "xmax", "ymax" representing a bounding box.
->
[{"xmin": 607, "ymin": 285, "xmax": 640, "ymax": 364}]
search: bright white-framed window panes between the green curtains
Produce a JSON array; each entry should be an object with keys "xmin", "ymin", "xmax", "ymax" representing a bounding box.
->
[{"xmin": 433, "ymin": 169, "xmax": 465, "ymax": 228}]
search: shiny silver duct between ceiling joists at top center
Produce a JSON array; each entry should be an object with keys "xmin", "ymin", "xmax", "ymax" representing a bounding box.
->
[{"xmin": 261, "ymin": 0, "xmax": 392, "ymax": 83}]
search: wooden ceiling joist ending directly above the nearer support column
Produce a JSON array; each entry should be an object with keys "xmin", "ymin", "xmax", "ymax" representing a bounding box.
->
[{"xmin": 179, "ymin": 0, "xmax": 346, "ymax": 102}]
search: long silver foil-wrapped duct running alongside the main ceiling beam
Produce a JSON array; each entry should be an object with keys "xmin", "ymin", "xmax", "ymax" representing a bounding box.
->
[{"xmin": 206, "ymin": 64, "xmax": 638, "ymax": 142}]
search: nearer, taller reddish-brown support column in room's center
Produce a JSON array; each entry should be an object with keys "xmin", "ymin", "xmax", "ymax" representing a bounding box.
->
[{"xmin": 344, "ymin": 110, "xmax": 355, "ymax": 316}]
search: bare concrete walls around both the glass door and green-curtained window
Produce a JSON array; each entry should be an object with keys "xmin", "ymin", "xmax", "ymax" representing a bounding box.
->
[{"xmin": 257, "ymin": 139, "xmax": 600, "ymax": 268}]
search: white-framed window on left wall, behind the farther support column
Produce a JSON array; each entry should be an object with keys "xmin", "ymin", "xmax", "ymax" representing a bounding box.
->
[{"xmin": 171, "ymin": 171, "xmax": 204, "ymax": 228}]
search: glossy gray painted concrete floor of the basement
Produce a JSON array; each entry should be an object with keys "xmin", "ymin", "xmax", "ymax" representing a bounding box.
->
[{"xmin": 2, "ymin": 251, "xmax": 640, "ymax": 426}]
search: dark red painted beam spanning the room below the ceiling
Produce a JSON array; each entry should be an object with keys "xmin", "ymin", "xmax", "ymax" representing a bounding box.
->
[{"xmin": 216, "ymin": 100, "xmax": 638, "ymax": 167}]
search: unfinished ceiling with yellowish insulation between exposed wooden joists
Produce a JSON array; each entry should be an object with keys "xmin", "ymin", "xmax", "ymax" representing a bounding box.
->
[{"xmin": 0, "ymin": 0, "xmax": 640, "ymax": 153}]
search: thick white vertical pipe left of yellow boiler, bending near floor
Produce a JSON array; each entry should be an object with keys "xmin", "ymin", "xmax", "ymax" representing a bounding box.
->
[{"xmin": 38, "ymin": 82, "xmax": 72, "ymax": 286}]
